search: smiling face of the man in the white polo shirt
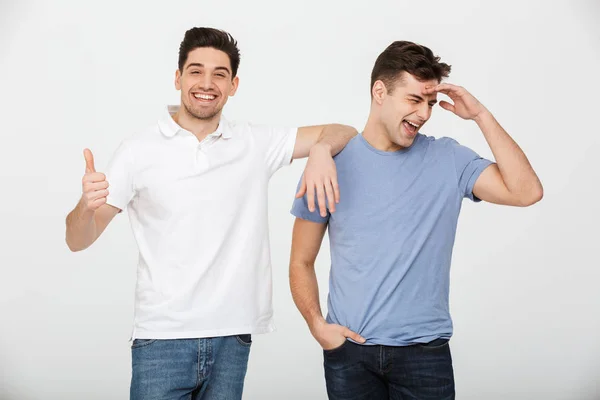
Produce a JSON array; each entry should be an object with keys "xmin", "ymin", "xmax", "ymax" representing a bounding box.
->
[{"xmin": 175, "ymin": 47, "xmax": 239, "ymax": 120}]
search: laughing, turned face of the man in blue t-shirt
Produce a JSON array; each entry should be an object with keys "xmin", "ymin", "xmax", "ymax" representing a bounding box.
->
[{"xmin": 373, "ymin": 72, "xmax": 439, "ymax": 148}]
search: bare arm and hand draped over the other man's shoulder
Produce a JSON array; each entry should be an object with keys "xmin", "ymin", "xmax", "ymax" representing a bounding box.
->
[{"xmin": 293, "ymin": 124, "xmax": 358, "ymax": 217}]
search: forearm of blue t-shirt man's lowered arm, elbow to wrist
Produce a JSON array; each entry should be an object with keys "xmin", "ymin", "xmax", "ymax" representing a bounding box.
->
[{"xmin": 290, "ymin": 261, "xmax": 325, "ymax": 332}]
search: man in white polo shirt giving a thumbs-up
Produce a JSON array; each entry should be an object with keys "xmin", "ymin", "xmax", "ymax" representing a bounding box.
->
[{"xmin": 66, "ymin": 28, "xmax": 357, "ymax": 400}]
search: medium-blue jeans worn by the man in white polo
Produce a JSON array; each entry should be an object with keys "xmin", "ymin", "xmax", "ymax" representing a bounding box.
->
[{"xmin": 130, "ymin": 335, "xmax": 252, "ymax": 400}]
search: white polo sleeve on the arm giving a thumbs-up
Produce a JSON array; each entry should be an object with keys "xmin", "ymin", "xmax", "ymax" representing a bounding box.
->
[{"xmin": 105, "ymin": 141, "xmax": 134, "ymax": 211}]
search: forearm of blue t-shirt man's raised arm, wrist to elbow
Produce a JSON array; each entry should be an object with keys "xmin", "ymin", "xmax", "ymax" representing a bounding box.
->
[{"xmin": 475, "ymin": 110, "xmax": 542, "ymax": 198}]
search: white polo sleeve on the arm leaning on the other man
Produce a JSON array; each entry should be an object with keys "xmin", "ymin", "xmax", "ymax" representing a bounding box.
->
[{"xmin": 250, "ymin": 125, "xmax": 298, "ymax": 175}]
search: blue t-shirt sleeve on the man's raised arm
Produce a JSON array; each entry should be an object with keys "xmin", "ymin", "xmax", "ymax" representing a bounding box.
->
[{"xmin": 450, "ymin": 139, "xmax": 494, "ymax": 202}]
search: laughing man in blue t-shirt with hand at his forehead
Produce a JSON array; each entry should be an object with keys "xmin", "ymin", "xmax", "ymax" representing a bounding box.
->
[{"xmin": 290, "ymin": 41, "xmax": 543, "ymax": 400}]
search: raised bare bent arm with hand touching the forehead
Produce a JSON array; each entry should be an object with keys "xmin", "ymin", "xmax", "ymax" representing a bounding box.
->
[{"xmin": 426, "ymin": 83, "xmax": 543, "ymax": 207}]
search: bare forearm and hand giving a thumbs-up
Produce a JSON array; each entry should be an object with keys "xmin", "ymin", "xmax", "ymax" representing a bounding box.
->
[{"xmin": 66, "ymin": 149, "xmax": 120, "ymax": 251}]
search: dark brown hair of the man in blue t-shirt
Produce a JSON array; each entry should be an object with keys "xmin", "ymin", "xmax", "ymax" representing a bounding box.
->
[{"xmin": 371, "ymin": 41, "xmax": 451, "ymax": 92}]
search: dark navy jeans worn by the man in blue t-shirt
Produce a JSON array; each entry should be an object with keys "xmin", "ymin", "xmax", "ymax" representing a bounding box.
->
[{"xmin": 323, "ymin": 339, "xmax": 455, "ymax": 400}]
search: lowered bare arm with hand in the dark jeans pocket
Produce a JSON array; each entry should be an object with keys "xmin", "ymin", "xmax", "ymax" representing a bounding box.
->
[{"xmin": 290, "ymin": 218, "xmax": 365, "ymax": 350}]
